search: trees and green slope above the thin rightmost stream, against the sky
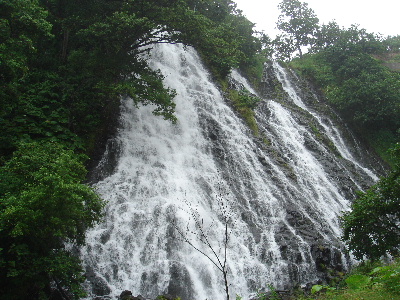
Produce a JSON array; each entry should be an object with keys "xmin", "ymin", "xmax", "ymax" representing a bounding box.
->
[{"xmin": 273, "ymin": 0, "xmax": 400, "ymax": 164}]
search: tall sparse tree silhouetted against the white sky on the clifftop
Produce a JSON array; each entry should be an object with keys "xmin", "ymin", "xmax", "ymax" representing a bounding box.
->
[{"xmin": 276, "ymin": 0, "xmax": 319, "ymax": 57}]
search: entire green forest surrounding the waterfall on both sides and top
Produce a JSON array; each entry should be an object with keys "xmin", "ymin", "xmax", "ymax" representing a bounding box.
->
[{"xmin": 0, "ymin": 0, "xmax": 400, "ymax": 300}]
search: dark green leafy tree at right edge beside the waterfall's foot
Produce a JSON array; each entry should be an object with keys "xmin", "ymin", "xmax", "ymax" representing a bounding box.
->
[{"xmin": 342, "ymin": 143, "xmax": 400, "ymax": 260}]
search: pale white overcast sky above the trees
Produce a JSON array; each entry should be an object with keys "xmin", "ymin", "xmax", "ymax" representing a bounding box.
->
[{"xmin": 234, "ymin": 0, "xmax": 400, "ymax": 37}]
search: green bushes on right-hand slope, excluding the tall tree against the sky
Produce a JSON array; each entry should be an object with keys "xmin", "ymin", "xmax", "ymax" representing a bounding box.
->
[{"xmin": 291, "ymin": 22, "xmax": 400, "ymax": 164}]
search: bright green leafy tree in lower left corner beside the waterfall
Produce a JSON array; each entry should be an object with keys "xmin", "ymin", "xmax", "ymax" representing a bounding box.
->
[{"xmin": 0, "ymin": 142, "xmax": 103, "ymax": 300}]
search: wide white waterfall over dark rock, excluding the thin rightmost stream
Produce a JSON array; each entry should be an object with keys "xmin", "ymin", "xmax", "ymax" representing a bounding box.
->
[{"xmin": 80, "ymin": 44, "xmax": 378, "ymax": 299}]
